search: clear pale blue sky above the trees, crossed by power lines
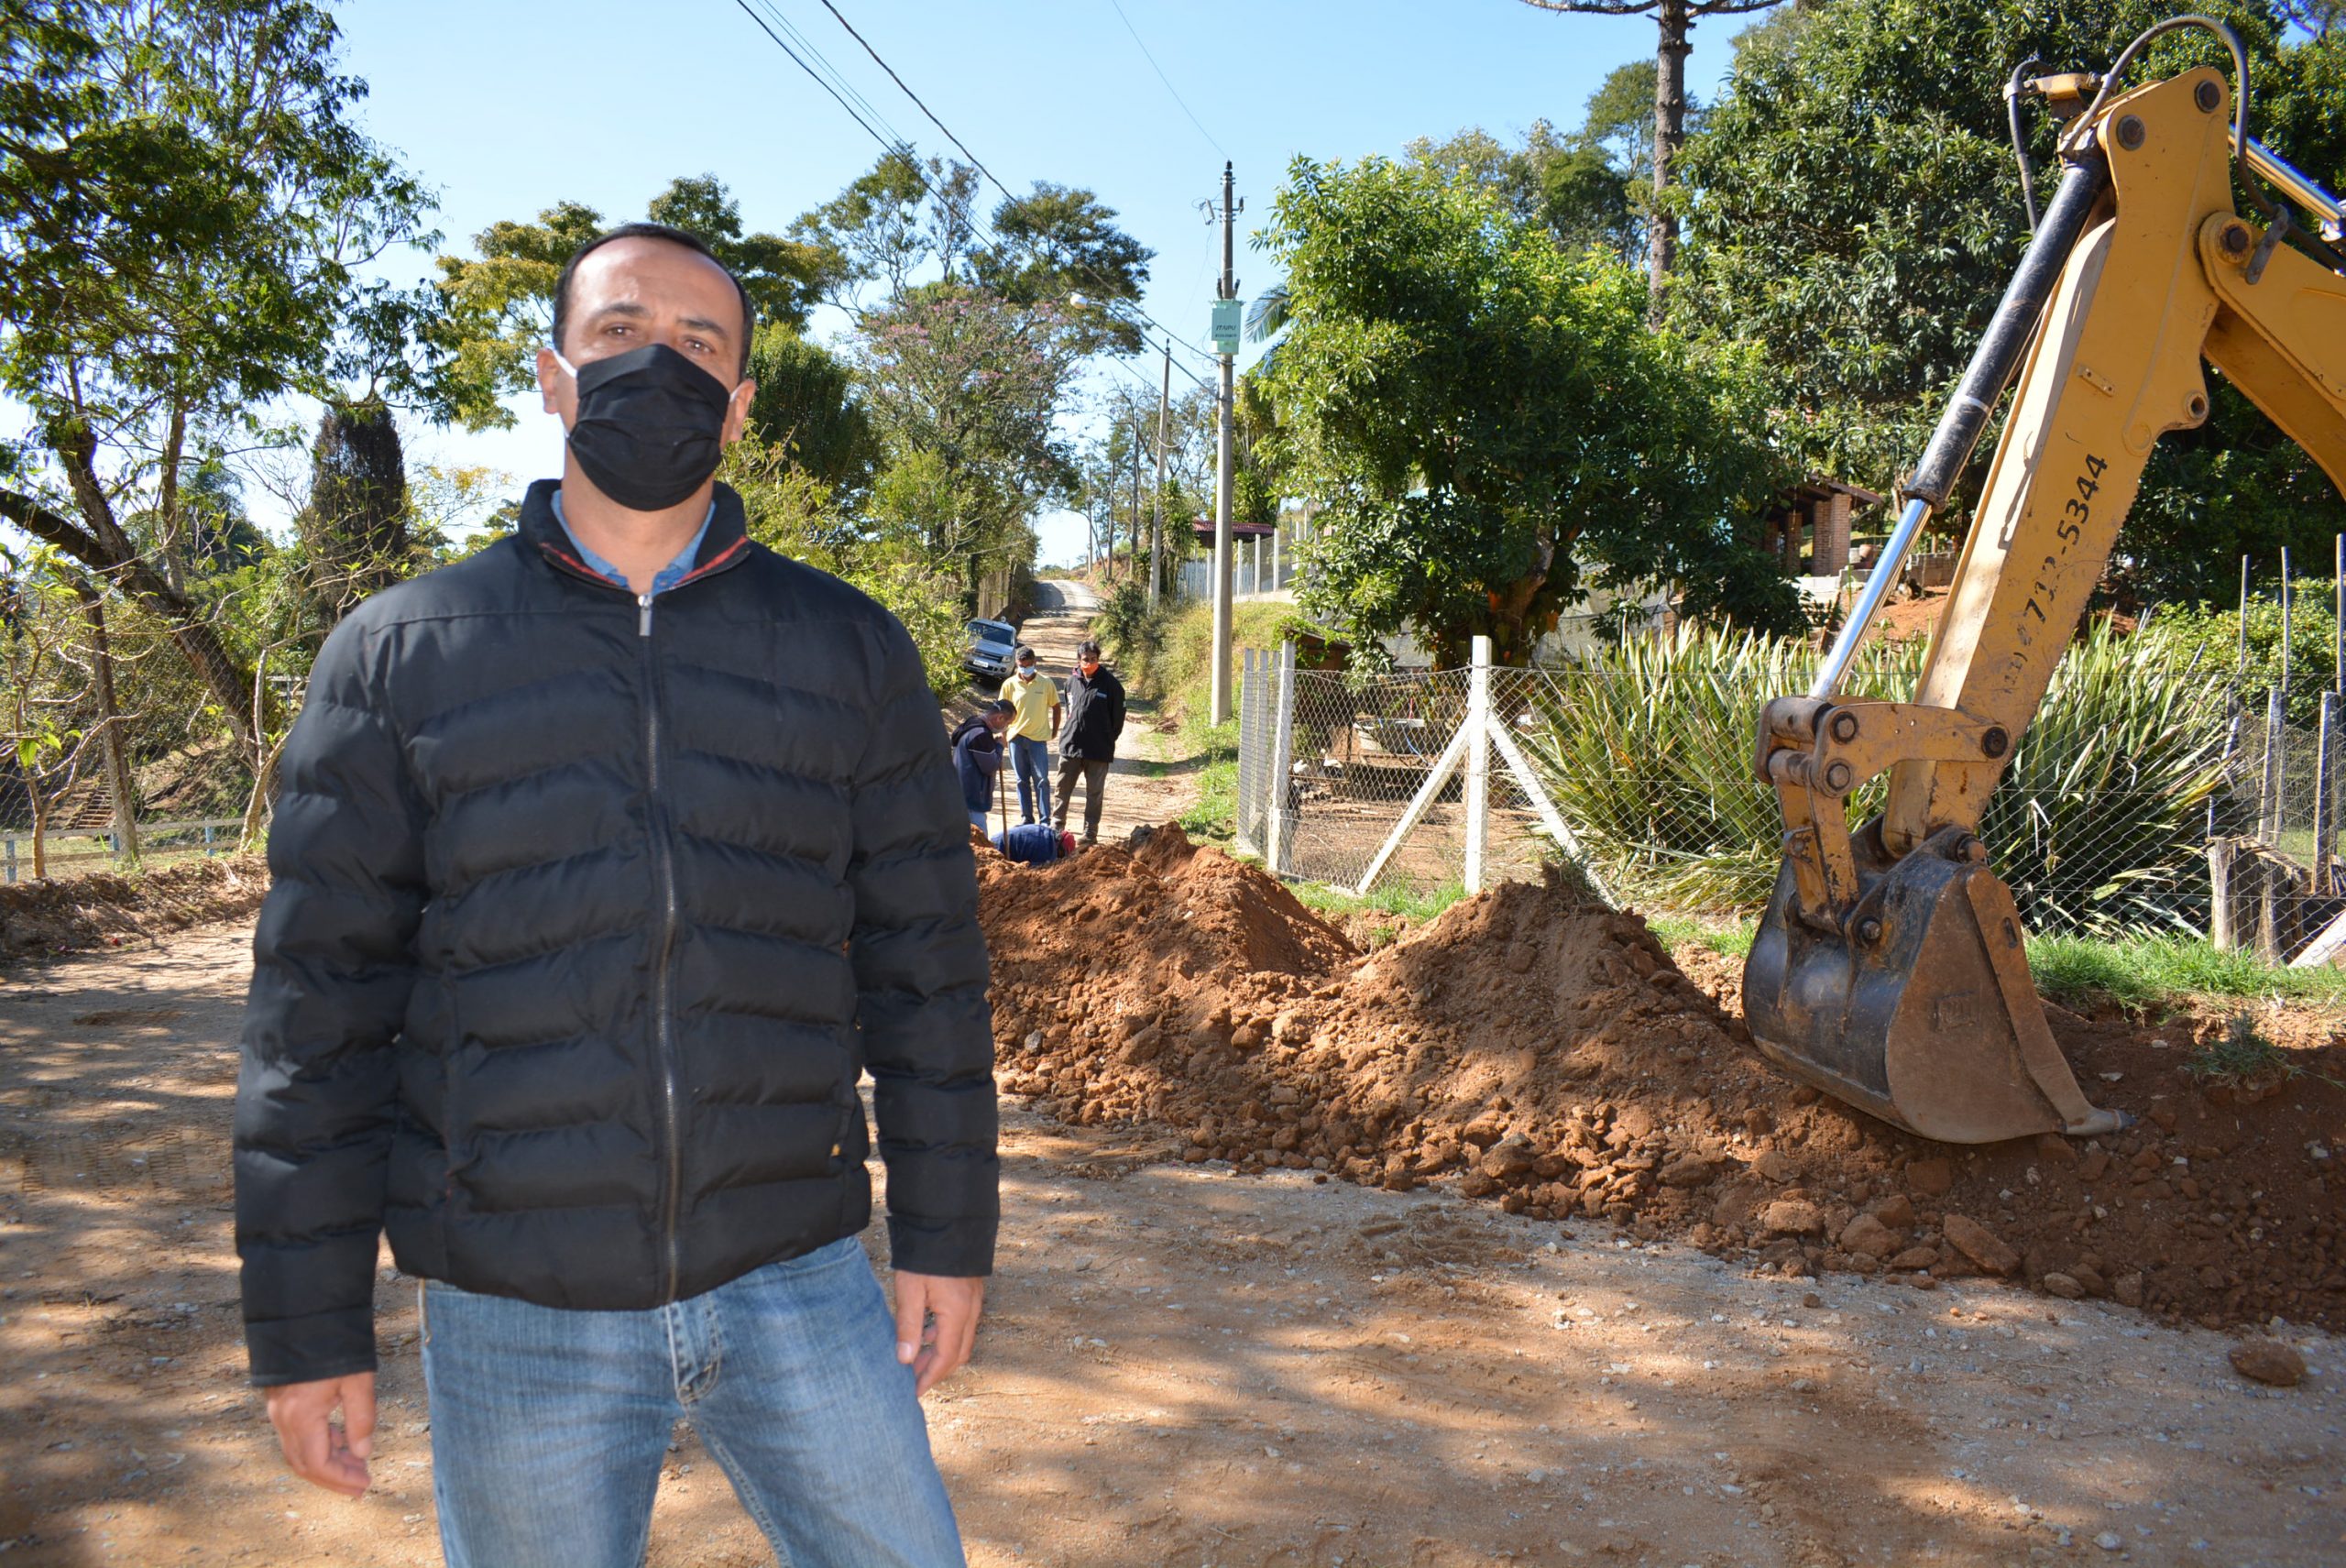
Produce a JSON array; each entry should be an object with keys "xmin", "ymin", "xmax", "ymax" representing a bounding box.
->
[{"xmin": 334, "ymin": 0, "xmax": 1750, "ymax": 561}]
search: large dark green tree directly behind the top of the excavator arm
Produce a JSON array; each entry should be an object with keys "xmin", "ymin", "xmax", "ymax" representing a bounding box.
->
[{"xmin": 1680, "ymin": 0, "xmax": 2346, "ymax": 597}]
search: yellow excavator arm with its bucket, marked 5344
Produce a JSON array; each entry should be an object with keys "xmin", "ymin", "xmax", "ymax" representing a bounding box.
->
[{"xmin": 1743, "ymin": 18, "xmax": 2346, "ymax": 1143}]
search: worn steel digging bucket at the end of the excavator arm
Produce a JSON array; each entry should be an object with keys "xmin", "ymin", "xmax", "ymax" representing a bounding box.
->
[{"xmin": 1743, "ymin": 833, "xmax": 2121, "ymax": 1143}]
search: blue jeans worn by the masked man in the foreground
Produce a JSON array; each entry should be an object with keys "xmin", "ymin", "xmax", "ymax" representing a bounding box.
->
[{"xmin": 424, "ymin": 1237, "xmax": 962, "ymax": 1568}]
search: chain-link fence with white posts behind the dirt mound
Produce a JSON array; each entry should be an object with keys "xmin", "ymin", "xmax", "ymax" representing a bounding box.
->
[{"xmin": 1236, "ymin": 633, "xmax": 2318, "ymax": 958}]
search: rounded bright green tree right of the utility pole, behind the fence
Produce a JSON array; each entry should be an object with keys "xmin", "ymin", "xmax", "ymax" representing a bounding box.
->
[{"xmin": 1266, "ymin": 159, "xmax": 1797, "ymax": 662}]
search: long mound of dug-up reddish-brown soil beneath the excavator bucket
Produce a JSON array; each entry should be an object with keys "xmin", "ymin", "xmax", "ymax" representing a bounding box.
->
[{"xmin": 979, "ymin": 827, "xmax": 2346, "ymax": 1329}]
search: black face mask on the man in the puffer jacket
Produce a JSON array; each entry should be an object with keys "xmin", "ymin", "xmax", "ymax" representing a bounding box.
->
[{"xmin": 554, "ymin": 343, "xmax": 732, "ymax": 511}]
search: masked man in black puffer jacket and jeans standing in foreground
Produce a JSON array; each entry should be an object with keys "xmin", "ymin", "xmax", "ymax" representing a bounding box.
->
[{"xmin": 235, "ymin": 225, "xmax": 997, "ymax": 1568}]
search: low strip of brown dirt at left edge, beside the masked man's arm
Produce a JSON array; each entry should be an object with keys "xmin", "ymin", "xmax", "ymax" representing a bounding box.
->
[{"xmin": 0, "ymin": 854, "xmax": 269, "ymax": 962}]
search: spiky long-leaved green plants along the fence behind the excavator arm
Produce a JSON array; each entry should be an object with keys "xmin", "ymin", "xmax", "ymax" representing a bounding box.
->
[{"xmin": 1522, "ymin": 629, "xmax": 2224, "ymax": 934}]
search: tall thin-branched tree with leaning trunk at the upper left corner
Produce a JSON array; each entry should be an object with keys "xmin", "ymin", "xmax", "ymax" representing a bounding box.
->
[{"xmin": 0, "ymin": 0, "xmax": 424, "ymax": 747}]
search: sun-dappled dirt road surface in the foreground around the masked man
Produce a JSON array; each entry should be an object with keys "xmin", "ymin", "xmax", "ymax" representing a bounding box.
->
[{"xmin": 0, "ymin": 929, "xmax": 2346, "ymax": 1568}]
